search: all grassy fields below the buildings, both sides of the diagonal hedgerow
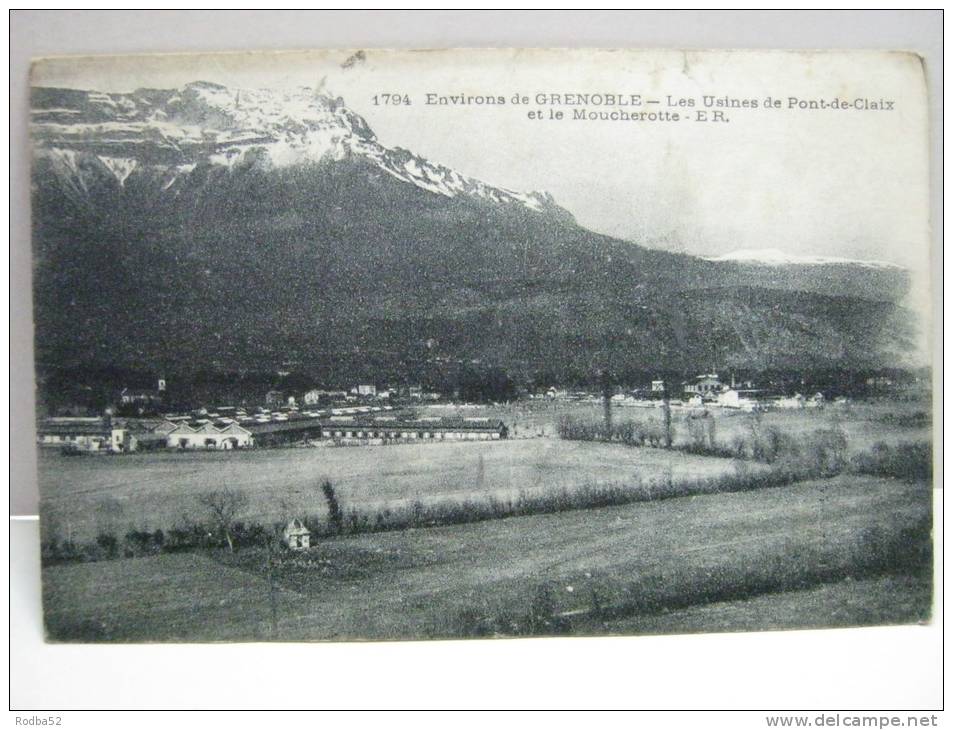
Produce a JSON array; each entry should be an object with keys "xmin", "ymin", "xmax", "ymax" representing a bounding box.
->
[{"xmin": 39, "ymin": 392, "xmax": 932, "ymax": 641}]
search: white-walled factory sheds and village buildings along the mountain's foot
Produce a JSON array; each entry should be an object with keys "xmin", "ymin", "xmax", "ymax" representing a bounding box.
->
[{"xmin": 37, "ymin": 373, "xmax": 843, "ymax": 453}]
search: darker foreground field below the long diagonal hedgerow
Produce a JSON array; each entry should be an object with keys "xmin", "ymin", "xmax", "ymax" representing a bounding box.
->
[{"xmin": 43, "ymin": 476, "xmax": 932, "ymax": 641}]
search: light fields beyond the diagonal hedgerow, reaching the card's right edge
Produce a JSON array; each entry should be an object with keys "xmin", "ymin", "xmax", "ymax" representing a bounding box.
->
[{"xmin": 39, "ymin": 401, "xmax": 930, "ymax": 542}]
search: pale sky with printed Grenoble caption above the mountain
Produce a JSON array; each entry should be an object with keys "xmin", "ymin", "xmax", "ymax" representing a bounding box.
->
[{"xmin": 33, "ymin": 50, "xmax": 929, "ymax": 288}]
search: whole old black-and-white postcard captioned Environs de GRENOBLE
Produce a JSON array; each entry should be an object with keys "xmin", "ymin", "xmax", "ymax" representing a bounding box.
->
[{"xmin": 30, "ymin": 50, "xmax": 934, "ymax": 642}]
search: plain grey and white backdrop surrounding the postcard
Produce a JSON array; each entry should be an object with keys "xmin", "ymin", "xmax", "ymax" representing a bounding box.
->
[{"xmin": 10, "ymin": 11, "xmax": 942, "ymax": 712}]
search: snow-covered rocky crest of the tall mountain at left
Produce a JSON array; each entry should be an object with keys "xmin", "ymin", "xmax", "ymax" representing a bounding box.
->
[{"xmin": 31, "ymin": 81, "xmax": 553, "ymax": 211}]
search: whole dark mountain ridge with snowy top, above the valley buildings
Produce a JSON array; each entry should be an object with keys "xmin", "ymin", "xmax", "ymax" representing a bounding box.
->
[{"xmin": 32, "ymin": 83, "xmax": 911, "ymax": 379}]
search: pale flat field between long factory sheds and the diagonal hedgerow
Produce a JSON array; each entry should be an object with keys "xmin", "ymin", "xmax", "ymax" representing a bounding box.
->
[{"xmin": 40, "ymin": 439, "xmax": 734, "ymax": 541}]
